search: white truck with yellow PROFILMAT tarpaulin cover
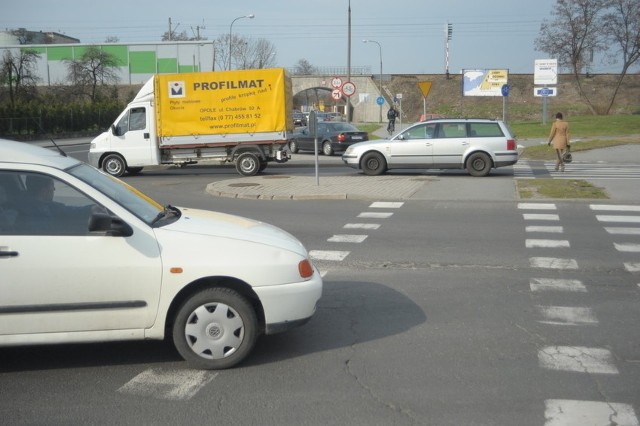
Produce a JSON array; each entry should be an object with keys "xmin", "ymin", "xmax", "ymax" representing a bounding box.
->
[{"xmin": 89, "ymin": 68, "xmax": 293, "ymax": 176}]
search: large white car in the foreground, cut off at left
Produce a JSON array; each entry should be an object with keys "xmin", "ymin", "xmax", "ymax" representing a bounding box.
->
[{"xmin": 0, "ymin": 140, "xmax": 322, "ymax": 369}]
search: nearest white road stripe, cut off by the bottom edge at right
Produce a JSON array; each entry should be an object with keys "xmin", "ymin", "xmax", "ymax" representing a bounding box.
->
[{"xmin": 544, "ymin": 399, "xmax": 639, "ymax": 426}]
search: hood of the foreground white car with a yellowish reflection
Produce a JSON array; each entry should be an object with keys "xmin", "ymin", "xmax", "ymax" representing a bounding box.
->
[{"xmin": 162, "ymin": 207, "xmax": 307, "ymax": 256}]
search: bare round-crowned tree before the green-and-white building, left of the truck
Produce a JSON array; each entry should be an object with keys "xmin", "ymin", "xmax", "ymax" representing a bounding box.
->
[{"xmin": 67, "ymin": 46, "xmax": 120, "ymax": 102}]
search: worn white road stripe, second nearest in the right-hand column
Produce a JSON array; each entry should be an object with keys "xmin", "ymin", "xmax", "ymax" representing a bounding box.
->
[{"xmin": 538, "ymin": 346, "xmax": 618, "ymax": 374}]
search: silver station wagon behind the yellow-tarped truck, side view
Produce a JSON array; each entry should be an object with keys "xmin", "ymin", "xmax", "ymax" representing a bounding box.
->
[{"xmin": 342, "ymin": 119, "xmax": 518, "ymax": 176}]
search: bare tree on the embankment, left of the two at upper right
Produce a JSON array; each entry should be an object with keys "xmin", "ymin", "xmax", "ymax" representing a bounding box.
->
[{"xmin": 535, "ymin": 0, "xmax": 610, "ymax": 114}]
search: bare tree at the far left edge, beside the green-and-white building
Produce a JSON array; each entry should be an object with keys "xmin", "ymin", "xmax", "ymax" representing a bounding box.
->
[{"xmin": 0, "ymin": 49, "xmax": 40, "ymax": 108}]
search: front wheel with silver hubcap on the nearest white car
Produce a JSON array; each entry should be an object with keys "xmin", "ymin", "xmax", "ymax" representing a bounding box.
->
[{"xmin": 173, "ymin": 288, "xmax": 258, "ymax": 370}]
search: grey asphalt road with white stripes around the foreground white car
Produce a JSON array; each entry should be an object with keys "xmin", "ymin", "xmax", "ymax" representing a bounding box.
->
[{"xmin": 0, "ymin": 141, "xmax": 640, "ymax": 426}]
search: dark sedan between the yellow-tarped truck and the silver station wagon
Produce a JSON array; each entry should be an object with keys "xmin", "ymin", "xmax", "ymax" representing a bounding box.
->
[{"xmin": 289, "ymin": 121, "xmax": 369, "ymax": 155}]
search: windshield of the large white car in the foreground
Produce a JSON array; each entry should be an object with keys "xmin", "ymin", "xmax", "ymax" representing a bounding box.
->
[{"xmin": 67, "ymin": 163, "xmax": 164, "ymax": 225}]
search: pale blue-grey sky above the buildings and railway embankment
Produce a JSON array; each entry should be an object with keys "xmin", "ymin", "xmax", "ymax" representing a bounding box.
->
[{"xmin": 0, "ymin": 0, "xmax": 619, "ymax": 74}]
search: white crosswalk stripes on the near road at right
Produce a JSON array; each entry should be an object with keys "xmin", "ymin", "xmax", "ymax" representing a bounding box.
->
[{"xmin": 518, "ymin": 203, "xmax": 640, "ymax": 426}]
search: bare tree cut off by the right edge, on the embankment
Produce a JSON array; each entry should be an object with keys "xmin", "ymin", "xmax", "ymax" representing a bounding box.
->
[{"xmin": 603, "ymin": 0, "xmax": 640, "ymax": 114}]
